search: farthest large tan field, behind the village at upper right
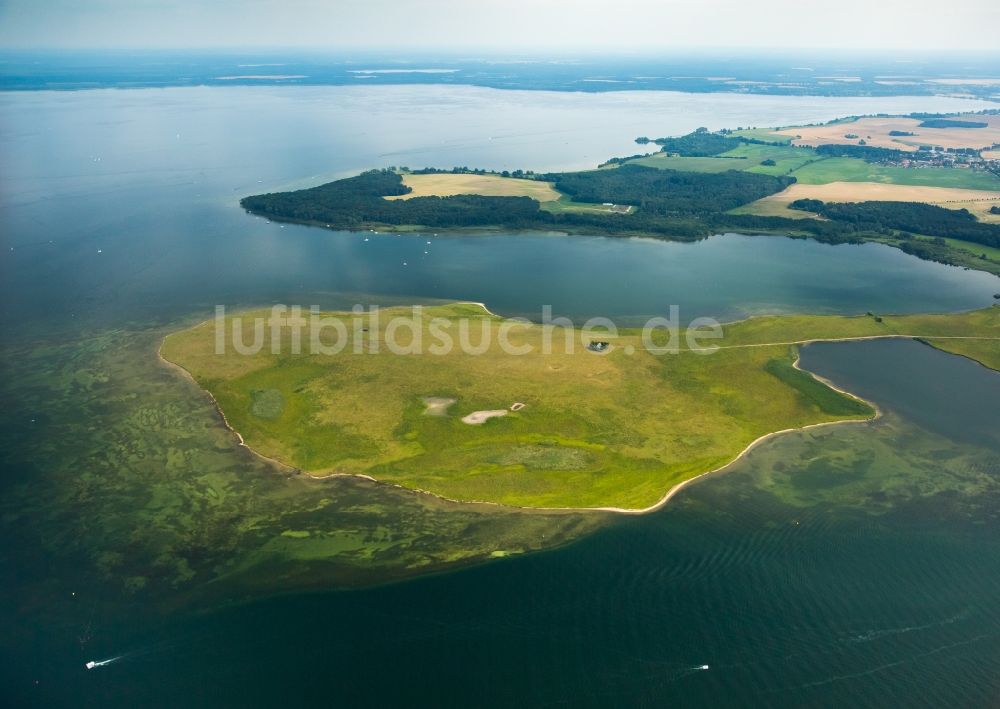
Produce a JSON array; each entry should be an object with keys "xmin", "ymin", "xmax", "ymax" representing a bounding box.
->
[{"xmin": 775, "ymin": 116, "xmax": 1000, "ymax": 151}]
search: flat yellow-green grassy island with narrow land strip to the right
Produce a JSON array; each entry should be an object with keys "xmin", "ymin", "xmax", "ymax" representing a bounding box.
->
[{"xmin": 161, "ymin": 304, "xmax": 1000, "ymax": 509}]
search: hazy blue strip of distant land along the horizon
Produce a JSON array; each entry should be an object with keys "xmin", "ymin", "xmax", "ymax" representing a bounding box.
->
[{"xmin": 0, "ymin": 49, "xmax": 997, "ymax": 101}]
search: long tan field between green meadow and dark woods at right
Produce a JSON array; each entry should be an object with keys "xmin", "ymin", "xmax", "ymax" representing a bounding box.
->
[{"xmin": 746, "ymin": 182, "xmax": 1000, "ymax": 215}]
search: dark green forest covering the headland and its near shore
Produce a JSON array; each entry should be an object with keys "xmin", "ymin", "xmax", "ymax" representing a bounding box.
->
[{"xmin": 240, "ymin": 164, "xmax": 1000, "ymax": 272}]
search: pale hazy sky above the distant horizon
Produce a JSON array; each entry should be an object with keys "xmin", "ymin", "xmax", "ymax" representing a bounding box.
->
[{"xmin": 0, "ymin": 0, "xmax": 1000, "ymax": 52}]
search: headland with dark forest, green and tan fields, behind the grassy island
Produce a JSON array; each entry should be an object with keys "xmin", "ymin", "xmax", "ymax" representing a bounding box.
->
[{"xmin": 240, "ymin": 113, "xmax": 1000, "ymax": 274}]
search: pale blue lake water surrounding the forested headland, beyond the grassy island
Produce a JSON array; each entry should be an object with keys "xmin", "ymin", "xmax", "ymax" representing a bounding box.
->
[{"xmin": 0, "ymin": 86, "xmax": 998, "ymax": 330}]
